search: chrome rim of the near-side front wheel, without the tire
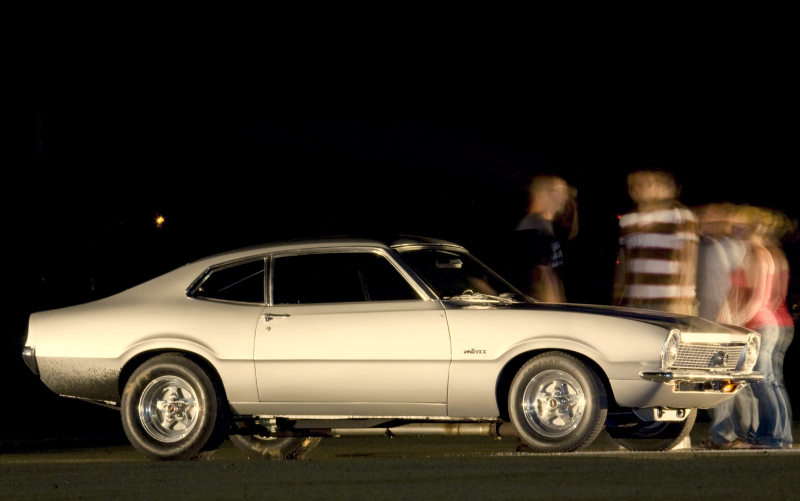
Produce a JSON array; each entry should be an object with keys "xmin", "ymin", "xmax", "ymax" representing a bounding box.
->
[{"xmin": 522, "ymin": 369, "xmax": 586, "ymax": 438}]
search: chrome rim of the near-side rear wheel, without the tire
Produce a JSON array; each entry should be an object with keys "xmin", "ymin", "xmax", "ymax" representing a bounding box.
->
[{"xmin": 139, "ymin": 376, "xmax": 203, "ymax": 443}]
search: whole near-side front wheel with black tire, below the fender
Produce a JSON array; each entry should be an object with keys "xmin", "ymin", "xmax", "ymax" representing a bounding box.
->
[{"xmin": 508, "ymin": 352, "xmax": 608, "ymax": 452}]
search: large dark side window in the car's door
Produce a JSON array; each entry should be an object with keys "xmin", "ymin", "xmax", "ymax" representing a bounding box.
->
[{"xmin": 272, "ymin": 252, "xmax": 420, "ymax": 305}]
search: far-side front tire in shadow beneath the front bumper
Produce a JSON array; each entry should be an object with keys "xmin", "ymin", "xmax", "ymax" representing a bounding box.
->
[{"xmin": 606, "ymin": 409, "xmax": 697, "ymax": 451}]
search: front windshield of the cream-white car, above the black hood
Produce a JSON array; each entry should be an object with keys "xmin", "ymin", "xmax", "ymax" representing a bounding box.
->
[{"xmin": 398, "ymin": 248, "xmax": 529, "ymax": 303}]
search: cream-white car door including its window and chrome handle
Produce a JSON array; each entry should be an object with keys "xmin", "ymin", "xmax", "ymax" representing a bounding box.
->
[{"xmin": 254, "ymin": 249, "xmax": 450, "ymax": 416}]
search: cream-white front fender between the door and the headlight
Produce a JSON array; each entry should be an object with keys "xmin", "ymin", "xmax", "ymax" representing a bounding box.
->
[{"xmin": 447, "ymin": 308, "xmax": 668, "ymax": 416}]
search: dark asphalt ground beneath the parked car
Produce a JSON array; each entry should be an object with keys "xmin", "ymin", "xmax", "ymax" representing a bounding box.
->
[{"xmin": 0, "ymin": 423, "xmax": 800, "ymax": 500}]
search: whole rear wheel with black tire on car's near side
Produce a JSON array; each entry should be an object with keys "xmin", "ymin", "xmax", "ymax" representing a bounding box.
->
[{"xmin": 120, "ymin": 353, "xmax": 229, "ymax": 459}]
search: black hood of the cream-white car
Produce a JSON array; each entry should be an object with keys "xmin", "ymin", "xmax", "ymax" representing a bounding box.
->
[{"xmin": 511, "ymin": 303, "xmax": 751, "ymax": 334}]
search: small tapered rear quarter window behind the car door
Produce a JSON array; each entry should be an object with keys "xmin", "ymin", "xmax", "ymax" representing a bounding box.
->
[{"xmin": 192, "ymin": 259, "xmax": 265, "ymax": 304}]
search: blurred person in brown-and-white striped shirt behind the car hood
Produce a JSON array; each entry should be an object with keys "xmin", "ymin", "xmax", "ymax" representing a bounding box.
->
[{"xmin": 613, "ymin": 169, "xmax": 699, "ymax": 315}]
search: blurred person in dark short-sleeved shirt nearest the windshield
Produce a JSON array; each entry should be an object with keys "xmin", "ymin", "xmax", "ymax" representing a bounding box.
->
[{"xmin": 512, "ymin": 175, "xmax": 577, "ymax": 302}]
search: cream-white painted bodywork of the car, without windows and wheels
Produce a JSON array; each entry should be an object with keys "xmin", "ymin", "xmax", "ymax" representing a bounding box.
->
[{"xmin": 26, "ymin": 236, "xmax": 754, "ymax": 419}]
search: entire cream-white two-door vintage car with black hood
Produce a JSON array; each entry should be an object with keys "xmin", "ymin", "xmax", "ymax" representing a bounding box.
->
[{"xmin": 23, "ymin": 237, "xmax": 761, "ymax": 459}]
